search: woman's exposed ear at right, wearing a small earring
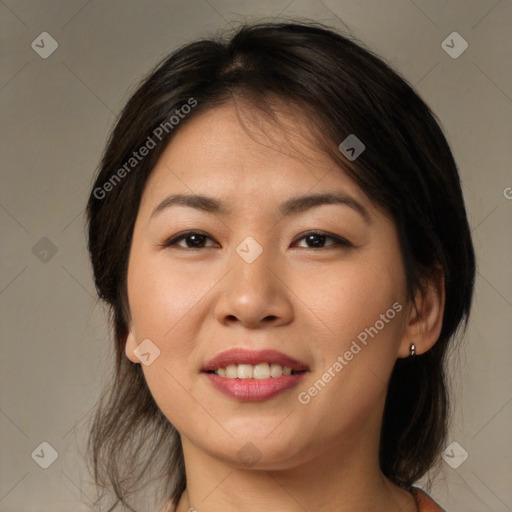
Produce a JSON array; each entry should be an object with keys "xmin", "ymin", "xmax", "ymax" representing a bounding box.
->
[{"xmin": 398, "ymin": 266, "xmax": 445, "ymax": 357}]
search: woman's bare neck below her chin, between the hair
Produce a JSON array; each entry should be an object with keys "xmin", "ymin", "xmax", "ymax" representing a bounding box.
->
[{"xmin": 176, "ymin": 424, "xmax": 417, "ymax": 512}]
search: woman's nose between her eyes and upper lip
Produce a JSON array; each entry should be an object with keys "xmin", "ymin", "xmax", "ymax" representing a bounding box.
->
[{"xmin": 215, "ymin": 246, "xmax": 294, "ymax": 329}]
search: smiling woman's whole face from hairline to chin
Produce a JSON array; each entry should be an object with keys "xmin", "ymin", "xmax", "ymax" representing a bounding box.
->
[{"xmin": 126, "ymin": 104, "xmax": 409, "ymax": 469}]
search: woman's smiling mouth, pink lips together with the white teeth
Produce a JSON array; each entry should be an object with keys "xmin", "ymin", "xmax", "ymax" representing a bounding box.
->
[{"xmin": 201, "ymin": 349, "xmax": 310, "ymax": 401}]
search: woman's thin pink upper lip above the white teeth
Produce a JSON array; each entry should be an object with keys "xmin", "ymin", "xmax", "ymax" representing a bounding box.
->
[{"xmin": 202, "ymin": 348, "xmax": 309, "ymax": 372}]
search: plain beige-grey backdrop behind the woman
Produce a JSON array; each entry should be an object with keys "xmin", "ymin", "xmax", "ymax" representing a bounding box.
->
[{"xmin": 0, "ymin": 0, "xmax": 512, "ymax": 512}]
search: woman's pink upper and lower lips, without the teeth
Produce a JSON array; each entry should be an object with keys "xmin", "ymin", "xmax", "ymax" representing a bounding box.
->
[{"xmin": 201, "ymin": 348, "xmax": 309, "ymax": 402}]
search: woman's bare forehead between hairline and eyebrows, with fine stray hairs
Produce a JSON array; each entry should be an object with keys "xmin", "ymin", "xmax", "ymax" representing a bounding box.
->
[{"xmin": 143, "ymin": 102, "xmax": 370, "ymax": 216}]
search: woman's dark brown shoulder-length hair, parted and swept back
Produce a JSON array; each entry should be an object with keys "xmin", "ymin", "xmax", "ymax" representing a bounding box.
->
[{"xmin": 87, "ymin": 22, "xmax": 475, "ymax": 510}]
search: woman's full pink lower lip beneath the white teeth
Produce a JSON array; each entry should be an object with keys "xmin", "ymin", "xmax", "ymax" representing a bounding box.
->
[{"xmin": 205, "ymin": 372, "xmax": 306, "ymax": 402}]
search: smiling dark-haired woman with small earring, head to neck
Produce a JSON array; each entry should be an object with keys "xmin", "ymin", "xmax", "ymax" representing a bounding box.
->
[{"xmin": 88, "ymin": 23, "xmax": 475, "ymax": 512}]
